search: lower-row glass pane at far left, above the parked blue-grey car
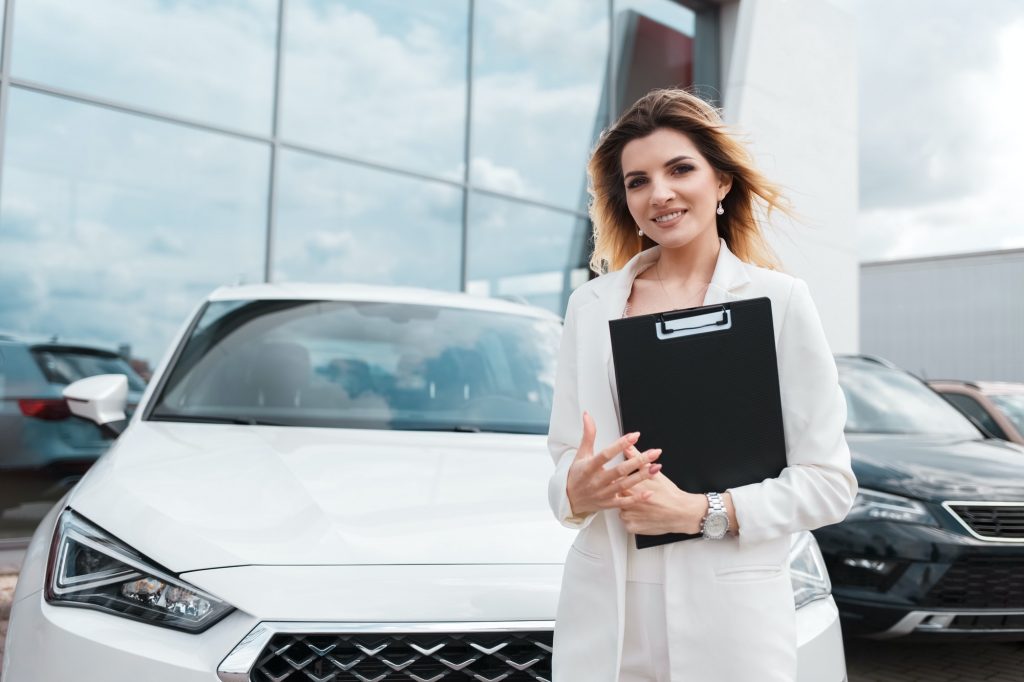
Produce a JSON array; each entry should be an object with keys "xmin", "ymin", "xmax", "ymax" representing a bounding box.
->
[{"xmin": 0, "ymin": 88, "xmax": 269, "ymax": 363}]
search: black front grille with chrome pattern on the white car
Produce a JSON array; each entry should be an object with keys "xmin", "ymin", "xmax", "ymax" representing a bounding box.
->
[{"xmin": 250, "ymin": 632, "xmax": 552, "ymax": 682}]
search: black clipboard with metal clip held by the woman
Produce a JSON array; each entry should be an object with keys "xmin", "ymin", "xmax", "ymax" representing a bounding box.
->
[{"xmin": 609, "ymin": 298, "xmax": 786, "ymax": 549}]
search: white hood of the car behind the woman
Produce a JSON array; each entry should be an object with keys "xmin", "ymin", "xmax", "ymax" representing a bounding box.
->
[{"xmin": 69, "ymin": 421, "xmax": 574, "ymax": 572}]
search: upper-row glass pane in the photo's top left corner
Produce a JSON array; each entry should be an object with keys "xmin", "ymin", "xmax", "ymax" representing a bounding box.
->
[{"xmin": 11, "ymin": 0, "xmax": 278, "ymax": 135}]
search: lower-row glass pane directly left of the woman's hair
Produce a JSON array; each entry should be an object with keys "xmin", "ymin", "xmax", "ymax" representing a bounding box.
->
[{"xmin": 467, "ymin": 194, "xmax": 590, "ymax": 314}]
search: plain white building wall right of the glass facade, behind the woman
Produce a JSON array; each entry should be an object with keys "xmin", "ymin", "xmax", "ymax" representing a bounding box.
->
[{"xmin": 722, "ymin": 0, "xmax": 859, "ymax": 352}]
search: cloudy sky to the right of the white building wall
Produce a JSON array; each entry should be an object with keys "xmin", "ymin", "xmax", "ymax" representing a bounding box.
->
[{"xmin": 843, "ymin": 0, "xmax": 1024, "ymax": 260}]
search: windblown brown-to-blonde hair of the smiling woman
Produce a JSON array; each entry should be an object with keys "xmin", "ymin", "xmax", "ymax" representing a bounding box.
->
[{"xmin": 587, "ymin": 89, "xmax": 792, "ymax": 273}]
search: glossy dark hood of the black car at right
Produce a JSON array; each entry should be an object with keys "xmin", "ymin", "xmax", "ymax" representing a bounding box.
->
[{"xmin": 847, "ymin": 433, "xmax": 1024, "ymax": 502}]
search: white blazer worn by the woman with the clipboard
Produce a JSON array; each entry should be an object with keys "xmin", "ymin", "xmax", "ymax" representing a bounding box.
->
[{"xmin": 548, "ymin": 236, "xmax": 857, "ymax": 682}]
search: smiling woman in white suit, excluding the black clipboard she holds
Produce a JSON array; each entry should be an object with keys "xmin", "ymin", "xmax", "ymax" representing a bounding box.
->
[{"xmin": 548, "ymin": 90, "xmax": 857, "ymax": 682}]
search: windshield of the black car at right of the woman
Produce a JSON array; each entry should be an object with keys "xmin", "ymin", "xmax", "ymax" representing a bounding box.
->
[{"xmin": 838, "ymin": 361, "xmax": 981, "ymax": 439}]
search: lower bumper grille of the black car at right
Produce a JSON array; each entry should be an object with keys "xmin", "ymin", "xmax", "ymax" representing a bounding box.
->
[{"xmin": 924, "ymin": 556, "xmax": 1024, "ymax": 609}]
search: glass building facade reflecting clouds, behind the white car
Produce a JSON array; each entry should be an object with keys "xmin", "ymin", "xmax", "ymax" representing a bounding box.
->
[{"xmin": 0, "ymin": 0, "xmax": 719, "ymax": 536}]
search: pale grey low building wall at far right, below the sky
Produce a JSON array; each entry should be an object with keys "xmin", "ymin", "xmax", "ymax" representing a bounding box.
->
[{"xmin": 860, "ymin": 249, "xmax": 1024, "ymax": 381}]
